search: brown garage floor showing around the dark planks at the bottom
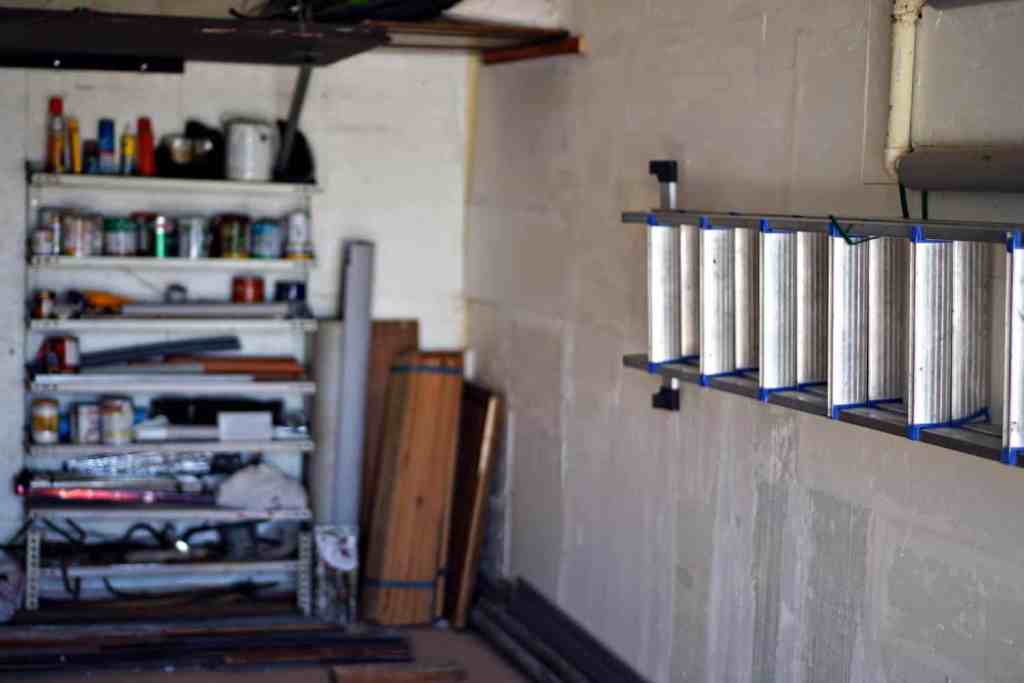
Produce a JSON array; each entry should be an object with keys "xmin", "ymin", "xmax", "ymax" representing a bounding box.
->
[{"xmin": 5, "ymin": 629, "xmax": 526, "ymax": 683}]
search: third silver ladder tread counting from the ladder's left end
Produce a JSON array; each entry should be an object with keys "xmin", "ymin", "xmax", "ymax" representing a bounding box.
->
[{"xmin": 700, "ymin": 225, "xmax": 736, "ymax": 377}]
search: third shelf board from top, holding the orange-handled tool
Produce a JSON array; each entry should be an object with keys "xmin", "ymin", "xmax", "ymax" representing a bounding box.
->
[{"xmin": 29, "ymin": 317, "xmax": 316, "ymax": 334}]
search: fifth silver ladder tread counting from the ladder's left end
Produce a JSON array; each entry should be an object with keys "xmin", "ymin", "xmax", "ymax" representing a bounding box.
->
[{"xmin": 758, "ymin": 231, "xmax": 798, "ymax": 390}]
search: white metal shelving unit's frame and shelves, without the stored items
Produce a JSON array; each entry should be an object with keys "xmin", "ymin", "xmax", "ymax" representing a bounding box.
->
[{"xmin": 25, "ymin": 167, "xmax": 322, "ymax": 615}]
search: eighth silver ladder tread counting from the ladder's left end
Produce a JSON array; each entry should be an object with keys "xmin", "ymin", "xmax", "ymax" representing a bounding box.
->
[{"xmin": 862, "ymin": 238, "xmax": 908, "ymax": 400}]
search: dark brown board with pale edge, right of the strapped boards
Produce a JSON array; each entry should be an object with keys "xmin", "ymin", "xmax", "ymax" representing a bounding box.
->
[{"xmin": 444, "ymin": 384, "xmax": 501, "ymax": 629}]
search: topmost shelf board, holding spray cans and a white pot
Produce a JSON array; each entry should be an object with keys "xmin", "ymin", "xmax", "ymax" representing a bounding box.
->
[{"xmin": 29, "ymin": 173, "xmax": 323, "ymax": 197}]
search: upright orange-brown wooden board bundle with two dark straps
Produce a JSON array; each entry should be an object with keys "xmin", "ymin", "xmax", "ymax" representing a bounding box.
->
[{"xmin": 362, "ymin": 352, "xmax": 463, "ymax": 625}]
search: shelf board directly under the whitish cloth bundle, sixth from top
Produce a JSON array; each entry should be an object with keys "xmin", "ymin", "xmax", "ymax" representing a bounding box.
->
[{"xmin": 29, "ymin": 506, "xmax": 312, "ymax": 522}]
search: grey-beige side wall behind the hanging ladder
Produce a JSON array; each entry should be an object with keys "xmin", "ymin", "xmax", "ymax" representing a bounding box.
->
[{"xmin": 466, "ymin": 0, "xmax": 1024, "ymax": 683}]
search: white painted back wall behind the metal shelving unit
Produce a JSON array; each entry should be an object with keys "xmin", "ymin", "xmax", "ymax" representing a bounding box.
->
[{"xmin": 0, "ymin": 50, "xmax": 470, "ymax": 538}]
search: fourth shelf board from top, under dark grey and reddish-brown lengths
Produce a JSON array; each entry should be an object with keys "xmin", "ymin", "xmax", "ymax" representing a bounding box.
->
[{"xmin": 30, "ymin": 375, "xmax": 316, "ymax": 396}]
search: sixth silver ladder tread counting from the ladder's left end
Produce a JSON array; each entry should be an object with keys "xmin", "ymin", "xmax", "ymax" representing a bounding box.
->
[{"xmin": 794, "ymin": 232, "xmax": 828, "ymax": 385}]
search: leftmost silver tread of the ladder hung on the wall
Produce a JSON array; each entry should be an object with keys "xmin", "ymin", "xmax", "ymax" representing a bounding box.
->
[{"xmin": 647, "ymin": 223, "xmax": 682, "ymax": 362}]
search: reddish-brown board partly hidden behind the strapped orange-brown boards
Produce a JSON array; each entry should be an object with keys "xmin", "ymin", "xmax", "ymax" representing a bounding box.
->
[{"xmin": 359, "ymin": 321, "xmax": 420, "ymax": 532}]
